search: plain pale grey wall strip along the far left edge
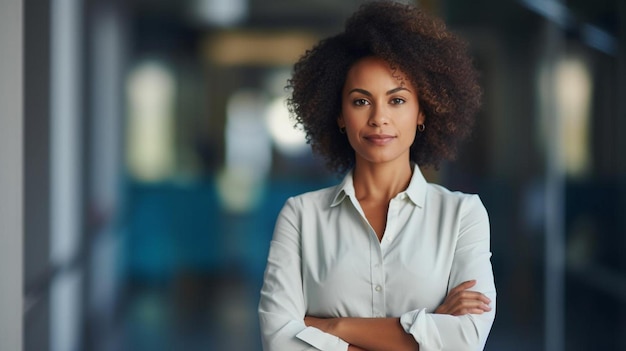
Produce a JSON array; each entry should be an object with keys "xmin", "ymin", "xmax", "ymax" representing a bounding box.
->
[{"xmin": 0, "ymin": 0, "xmax": 23, "ymax": 350}]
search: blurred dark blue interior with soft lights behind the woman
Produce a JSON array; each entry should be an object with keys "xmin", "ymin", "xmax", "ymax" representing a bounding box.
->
[{"xmin": 9, "ymin": 0, "xmax": 626, "ymax": 351}]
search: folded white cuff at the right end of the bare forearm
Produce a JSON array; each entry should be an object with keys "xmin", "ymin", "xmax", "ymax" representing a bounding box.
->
[{"xmin": 400, "ymin": 309, "xmax": 443, "ymax": 351}]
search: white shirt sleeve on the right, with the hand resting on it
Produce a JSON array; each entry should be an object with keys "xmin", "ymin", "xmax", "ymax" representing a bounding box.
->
[{"xmin": 400, "ymin": 195, "xmax": 496, "ymax": 351}]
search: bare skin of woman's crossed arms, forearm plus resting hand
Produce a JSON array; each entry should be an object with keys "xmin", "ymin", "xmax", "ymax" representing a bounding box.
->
[{"xmin": 304, "ymin": 280, "xmax": 491, "ymax": 351}]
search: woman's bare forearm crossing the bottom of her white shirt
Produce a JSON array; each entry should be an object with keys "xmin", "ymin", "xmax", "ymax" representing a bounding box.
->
[{"xmin": 306, "ymin": 318, "xmax": 419, "ymax": 351}]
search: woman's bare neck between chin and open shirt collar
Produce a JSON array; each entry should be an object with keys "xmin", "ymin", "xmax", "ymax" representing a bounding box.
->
[{"xmin": 352, "ymin": 162, "xmax": 413, "ymax": 201}]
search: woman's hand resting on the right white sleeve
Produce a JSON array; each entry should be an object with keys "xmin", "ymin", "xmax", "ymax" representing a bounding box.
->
[{"xmin": 435, "ymin": 280, "xmax": 491, "ymax": 316}]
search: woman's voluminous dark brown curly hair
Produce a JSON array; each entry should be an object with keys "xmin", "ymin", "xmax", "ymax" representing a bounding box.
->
[{"xmin": 287, "ymin": 1, "xmax": 482, "ymax": 173}]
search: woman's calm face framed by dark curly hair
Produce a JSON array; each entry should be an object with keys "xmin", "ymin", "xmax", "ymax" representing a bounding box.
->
[{"xmin": 337, "ymin": 57, "xmax": 424, "ymax": 165}]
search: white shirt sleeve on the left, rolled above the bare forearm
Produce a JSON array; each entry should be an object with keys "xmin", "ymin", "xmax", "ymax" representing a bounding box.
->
[{"xmin": 259, "ymin": 198, "xmax": 348, "ymax": 351}]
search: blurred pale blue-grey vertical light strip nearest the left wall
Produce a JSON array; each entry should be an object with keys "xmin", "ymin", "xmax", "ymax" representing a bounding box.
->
[{"xmin": 50, "ymin": 0, "xmax": 83, "ymax": 351}]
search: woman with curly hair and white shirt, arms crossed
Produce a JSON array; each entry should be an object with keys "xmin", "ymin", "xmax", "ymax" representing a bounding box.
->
[{"xmin": 259, "ymin": 2, "xmax": 496, "ymax": 351}]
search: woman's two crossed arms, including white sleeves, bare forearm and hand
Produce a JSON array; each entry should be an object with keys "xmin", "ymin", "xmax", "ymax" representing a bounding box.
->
[{"xmin": 259, "ymin": 198, "xmax": 496, "ymax": 351}]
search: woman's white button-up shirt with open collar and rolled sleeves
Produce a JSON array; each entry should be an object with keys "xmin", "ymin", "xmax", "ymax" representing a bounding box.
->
[{"xmin": 259, "ymin": 167, "xmax": 496, "ymax": 351}]
